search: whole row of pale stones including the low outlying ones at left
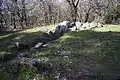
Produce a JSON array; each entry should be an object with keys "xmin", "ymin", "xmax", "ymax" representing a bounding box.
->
[{"xmin": 11, "ymin": 21, "xmax": 103, "ymax": 49}]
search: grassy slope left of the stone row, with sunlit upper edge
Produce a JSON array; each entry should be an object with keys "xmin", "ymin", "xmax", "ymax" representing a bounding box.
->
[{"xmin": 0, "ymin": 27, "xmax": 48, "ymax": 54}]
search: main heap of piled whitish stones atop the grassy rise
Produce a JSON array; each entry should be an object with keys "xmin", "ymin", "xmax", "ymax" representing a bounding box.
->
[{"xmin": 48, "ymin": 21, "xmax": 103, "ymax": 38}]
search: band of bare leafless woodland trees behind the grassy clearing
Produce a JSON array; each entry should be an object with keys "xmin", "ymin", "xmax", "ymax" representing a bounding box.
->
[{"xmin": 0, "ymin": 0, "xmax": 119, "ymax": 29}]
